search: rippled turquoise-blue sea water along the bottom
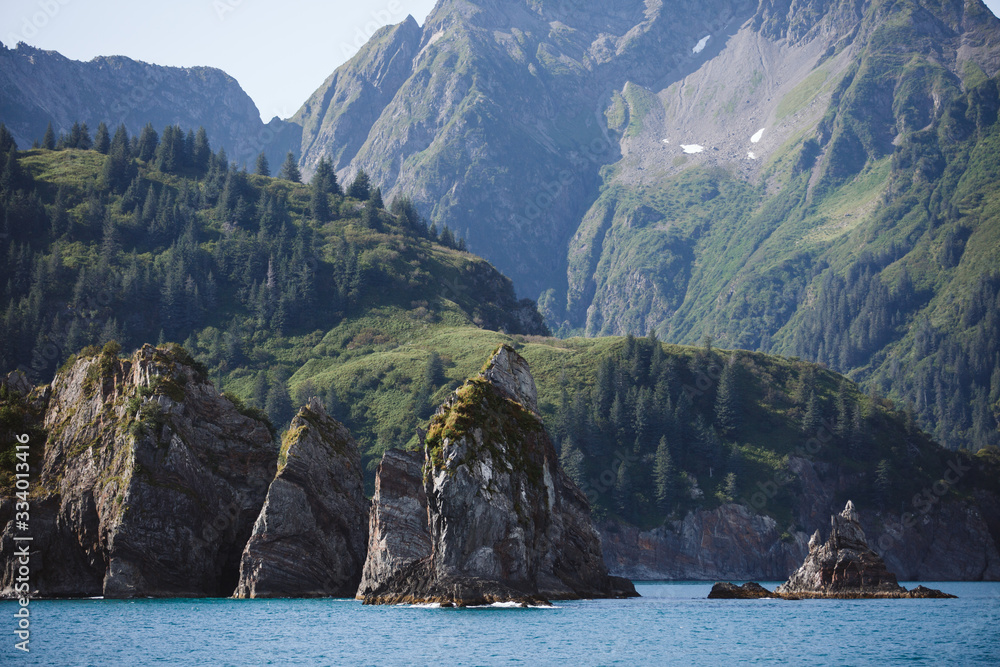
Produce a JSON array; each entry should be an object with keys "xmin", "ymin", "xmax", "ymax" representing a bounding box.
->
[{"xmin": 0, "ymin": 582, "xmax": 1000, "ymax": 667}]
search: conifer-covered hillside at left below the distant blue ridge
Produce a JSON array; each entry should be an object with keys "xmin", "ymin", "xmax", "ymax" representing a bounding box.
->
[{"xmin": 0, "ymin": 125, "xmax": 545, "ymax": 452}]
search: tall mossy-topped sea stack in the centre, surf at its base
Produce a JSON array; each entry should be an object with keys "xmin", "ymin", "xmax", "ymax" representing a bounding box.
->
[{"xmin": 358, "ymin": 345, "xmax": 636, "ymax": 606}]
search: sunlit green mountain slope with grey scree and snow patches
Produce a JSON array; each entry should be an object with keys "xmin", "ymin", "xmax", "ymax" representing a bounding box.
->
[{"xmin": 566, "ymin": 2, "xmax": 1000, "ymax": 448}]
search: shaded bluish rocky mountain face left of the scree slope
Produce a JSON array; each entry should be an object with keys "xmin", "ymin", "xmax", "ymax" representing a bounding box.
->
[{"xmin": 293, "ymin": 0, "xmax": 753, "ymax": 295}]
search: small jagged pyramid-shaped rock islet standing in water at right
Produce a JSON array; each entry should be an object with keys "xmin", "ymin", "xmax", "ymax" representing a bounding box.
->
[{"xmin": 775, "ymin": 501, "xmax": 954, "ymax": 598}]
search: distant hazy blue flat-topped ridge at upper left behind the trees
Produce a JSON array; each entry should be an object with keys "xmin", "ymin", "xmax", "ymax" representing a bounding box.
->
[{"xmin": 0, "ymin": 42, "xmax": 301, "ymax": 166}]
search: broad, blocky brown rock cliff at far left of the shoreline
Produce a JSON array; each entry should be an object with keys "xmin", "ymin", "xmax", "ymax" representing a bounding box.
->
[{"xmin": 0, "ymin": 345, "xmax": 275, "ymax": 598}]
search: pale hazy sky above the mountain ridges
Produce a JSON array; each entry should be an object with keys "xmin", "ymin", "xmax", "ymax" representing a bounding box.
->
[{"xmin": 0, "ymin": 0, "xmax": 1000, "ymax": 120}]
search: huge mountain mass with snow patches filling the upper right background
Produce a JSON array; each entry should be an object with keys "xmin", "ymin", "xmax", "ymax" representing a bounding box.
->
[{"xmin": 293, "ymin": 0, "xmax": 1000, "ymax": 448}]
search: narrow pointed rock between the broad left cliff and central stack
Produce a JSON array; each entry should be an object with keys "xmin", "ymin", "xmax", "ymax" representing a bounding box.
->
[{"xmin": 236, "ymin": 397, "xmax": 368, "ymax": 598}]
